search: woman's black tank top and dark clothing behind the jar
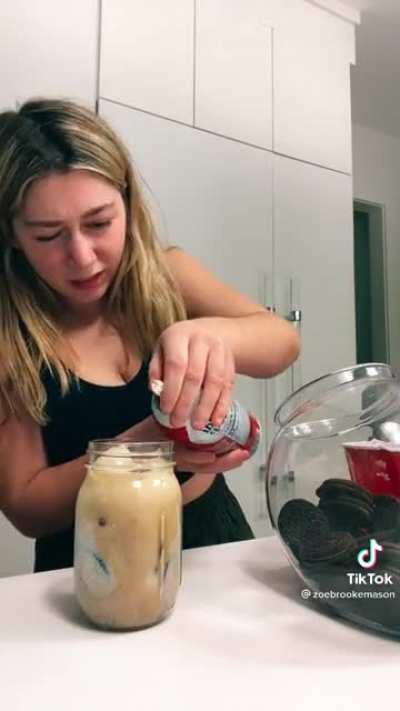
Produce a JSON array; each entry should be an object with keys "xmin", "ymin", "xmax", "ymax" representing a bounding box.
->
[{"xmin": 35, "ymin": 362, "xmax": 253, "ymax": 572}]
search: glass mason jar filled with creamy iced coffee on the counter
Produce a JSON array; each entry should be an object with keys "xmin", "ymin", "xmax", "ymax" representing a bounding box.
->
[{"xmin": 74, "ymin": 440, "xmax": 182, "ymax": 629}]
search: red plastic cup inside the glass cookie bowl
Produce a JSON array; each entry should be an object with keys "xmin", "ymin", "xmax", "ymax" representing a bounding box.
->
[{"xmin": 343, "ymin": 443, "xmax": 400, "ymax": 499}]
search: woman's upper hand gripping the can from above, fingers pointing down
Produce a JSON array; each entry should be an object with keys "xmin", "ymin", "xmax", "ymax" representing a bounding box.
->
[{"xmin": 149, "ymin": 319, "xmax": 235, "ymax": 428}]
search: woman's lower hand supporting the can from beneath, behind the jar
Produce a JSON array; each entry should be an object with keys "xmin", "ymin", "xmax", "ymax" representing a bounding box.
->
[{"xmin": 122, "ymin": 415, "xmax": 250, "ymax": 474}]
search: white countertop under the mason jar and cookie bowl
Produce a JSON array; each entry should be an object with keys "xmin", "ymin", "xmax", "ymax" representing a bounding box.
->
[{"xmin": 0, "ymin": 537, "xmax": 400, "ymax": 711}]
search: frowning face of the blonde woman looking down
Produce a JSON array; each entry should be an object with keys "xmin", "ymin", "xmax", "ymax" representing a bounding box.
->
[{"xmin": 13, "ymin": 170, "xmax": 126, "ymax": 313}]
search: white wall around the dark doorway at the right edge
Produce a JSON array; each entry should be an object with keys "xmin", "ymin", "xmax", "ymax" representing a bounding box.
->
[{"xmin": 353, "ymin": 124, "xmax": 400, "ymax": 368}]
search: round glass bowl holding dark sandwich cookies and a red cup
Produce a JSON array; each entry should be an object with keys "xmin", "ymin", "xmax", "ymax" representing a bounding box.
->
[{"xmin": 266, "ymin": 363, "xmax": 400, "ymax": 636}]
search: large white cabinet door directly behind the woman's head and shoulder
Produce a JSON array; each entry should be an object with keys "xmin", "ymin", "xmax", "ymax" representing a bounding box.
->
[{"xmin": 100, "ymin": 101, "xmax": 272, "ymax": 535}]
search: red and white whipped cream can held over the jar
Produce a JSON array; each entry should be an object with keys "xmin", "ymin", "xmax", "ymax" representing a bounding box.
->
[{"xmin": 150, "ymin": 380, "xmax": 261, "ymax": 454}]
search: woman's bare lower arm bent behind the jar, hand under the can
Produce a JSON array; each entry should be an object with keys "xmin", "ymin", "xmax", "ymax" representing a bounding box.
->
[{"xmin": 0, "ymin": 416, "xmax": 243, "ymax": 538}]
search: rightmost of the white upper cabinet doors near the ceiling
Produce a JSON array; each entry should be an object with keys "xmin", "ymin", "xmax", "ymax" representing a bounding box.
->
[{"xmin": 273, "ymin": 3, "xmax": 355, "ymax": 173}]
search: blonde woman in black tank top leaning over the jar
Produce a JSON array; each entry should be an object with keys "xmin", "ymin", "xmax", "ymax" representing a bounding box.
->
[{"xmin": 0, "ymin": 100, "xmax": 299, "ymax": 571}]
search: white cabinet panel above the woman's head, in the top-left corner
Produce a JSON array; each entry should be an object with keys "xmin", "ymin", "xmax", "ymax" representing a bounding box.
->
[{"xmin": 0, "ymin": 0, "xmax": 98, "ymax": 109}]
